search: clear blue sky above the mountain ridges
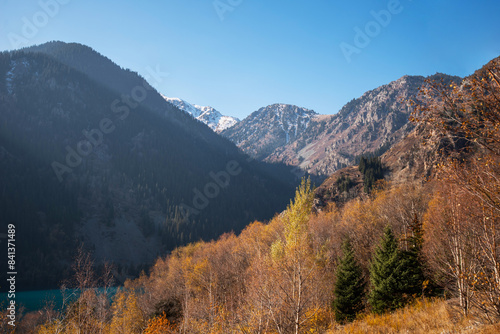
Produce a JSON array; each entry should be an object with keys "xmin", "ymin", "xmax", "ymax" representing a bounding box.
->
[{"xmin": 0, "ymin": 0, "xmax": 500, "ymax": 118}]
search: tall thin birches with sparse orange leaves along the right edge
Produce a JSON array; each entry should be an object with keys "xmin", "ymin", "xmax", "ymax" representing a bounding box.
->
[{"xmin": 414, "ymin": 58, "xmax": 500, "ymax": 321}]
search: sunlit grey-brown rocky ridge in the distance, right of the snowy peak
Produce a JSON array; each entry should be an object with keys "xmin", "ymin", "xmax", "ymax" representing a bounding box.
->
[{"xmin": 222, "ymin": 74, "xmax": 459, "ymax": 175}]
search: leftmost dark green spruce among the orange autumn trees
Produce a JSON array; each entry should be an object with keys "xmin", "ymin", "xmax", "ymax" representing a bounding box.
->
[{"xmin": 332, "ymin": 239, "xmax": 365, "ymax": 323}]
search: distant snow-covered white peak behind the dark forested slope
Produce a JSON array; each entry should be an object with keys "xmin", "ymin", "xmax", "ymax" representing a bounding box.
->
[{"xmin": 162, "ymin": 95, "xmax": 240, "ymax": 133}]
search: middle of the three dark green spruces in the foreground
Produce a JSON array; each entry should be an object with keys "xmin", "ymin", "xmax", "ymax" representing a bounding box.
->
[{"xmin": 368, "ymin": 226, "xmax": 401, "ymax": 313}]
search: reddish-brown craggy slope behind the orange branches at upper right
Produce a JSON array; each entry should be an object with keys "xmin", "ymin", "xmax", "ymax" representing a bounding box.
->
[{"xmin": 381, "ymin": 57, "xmax": 500, "ymax": 184}]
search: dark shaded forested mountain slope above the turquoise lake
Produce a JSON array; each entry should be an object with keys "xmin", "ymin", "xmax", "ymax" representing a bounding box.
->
[{"xmin": 0, "ymin": 43, "xmax": 296, "ymax": 288}]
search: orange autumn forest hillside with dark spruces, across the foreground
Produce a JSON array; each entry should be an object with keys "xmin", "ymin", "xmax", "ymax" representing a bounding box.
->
[{"xmin": 29, "ymin": 60, "xmax": 500, "ymax": 334}]
